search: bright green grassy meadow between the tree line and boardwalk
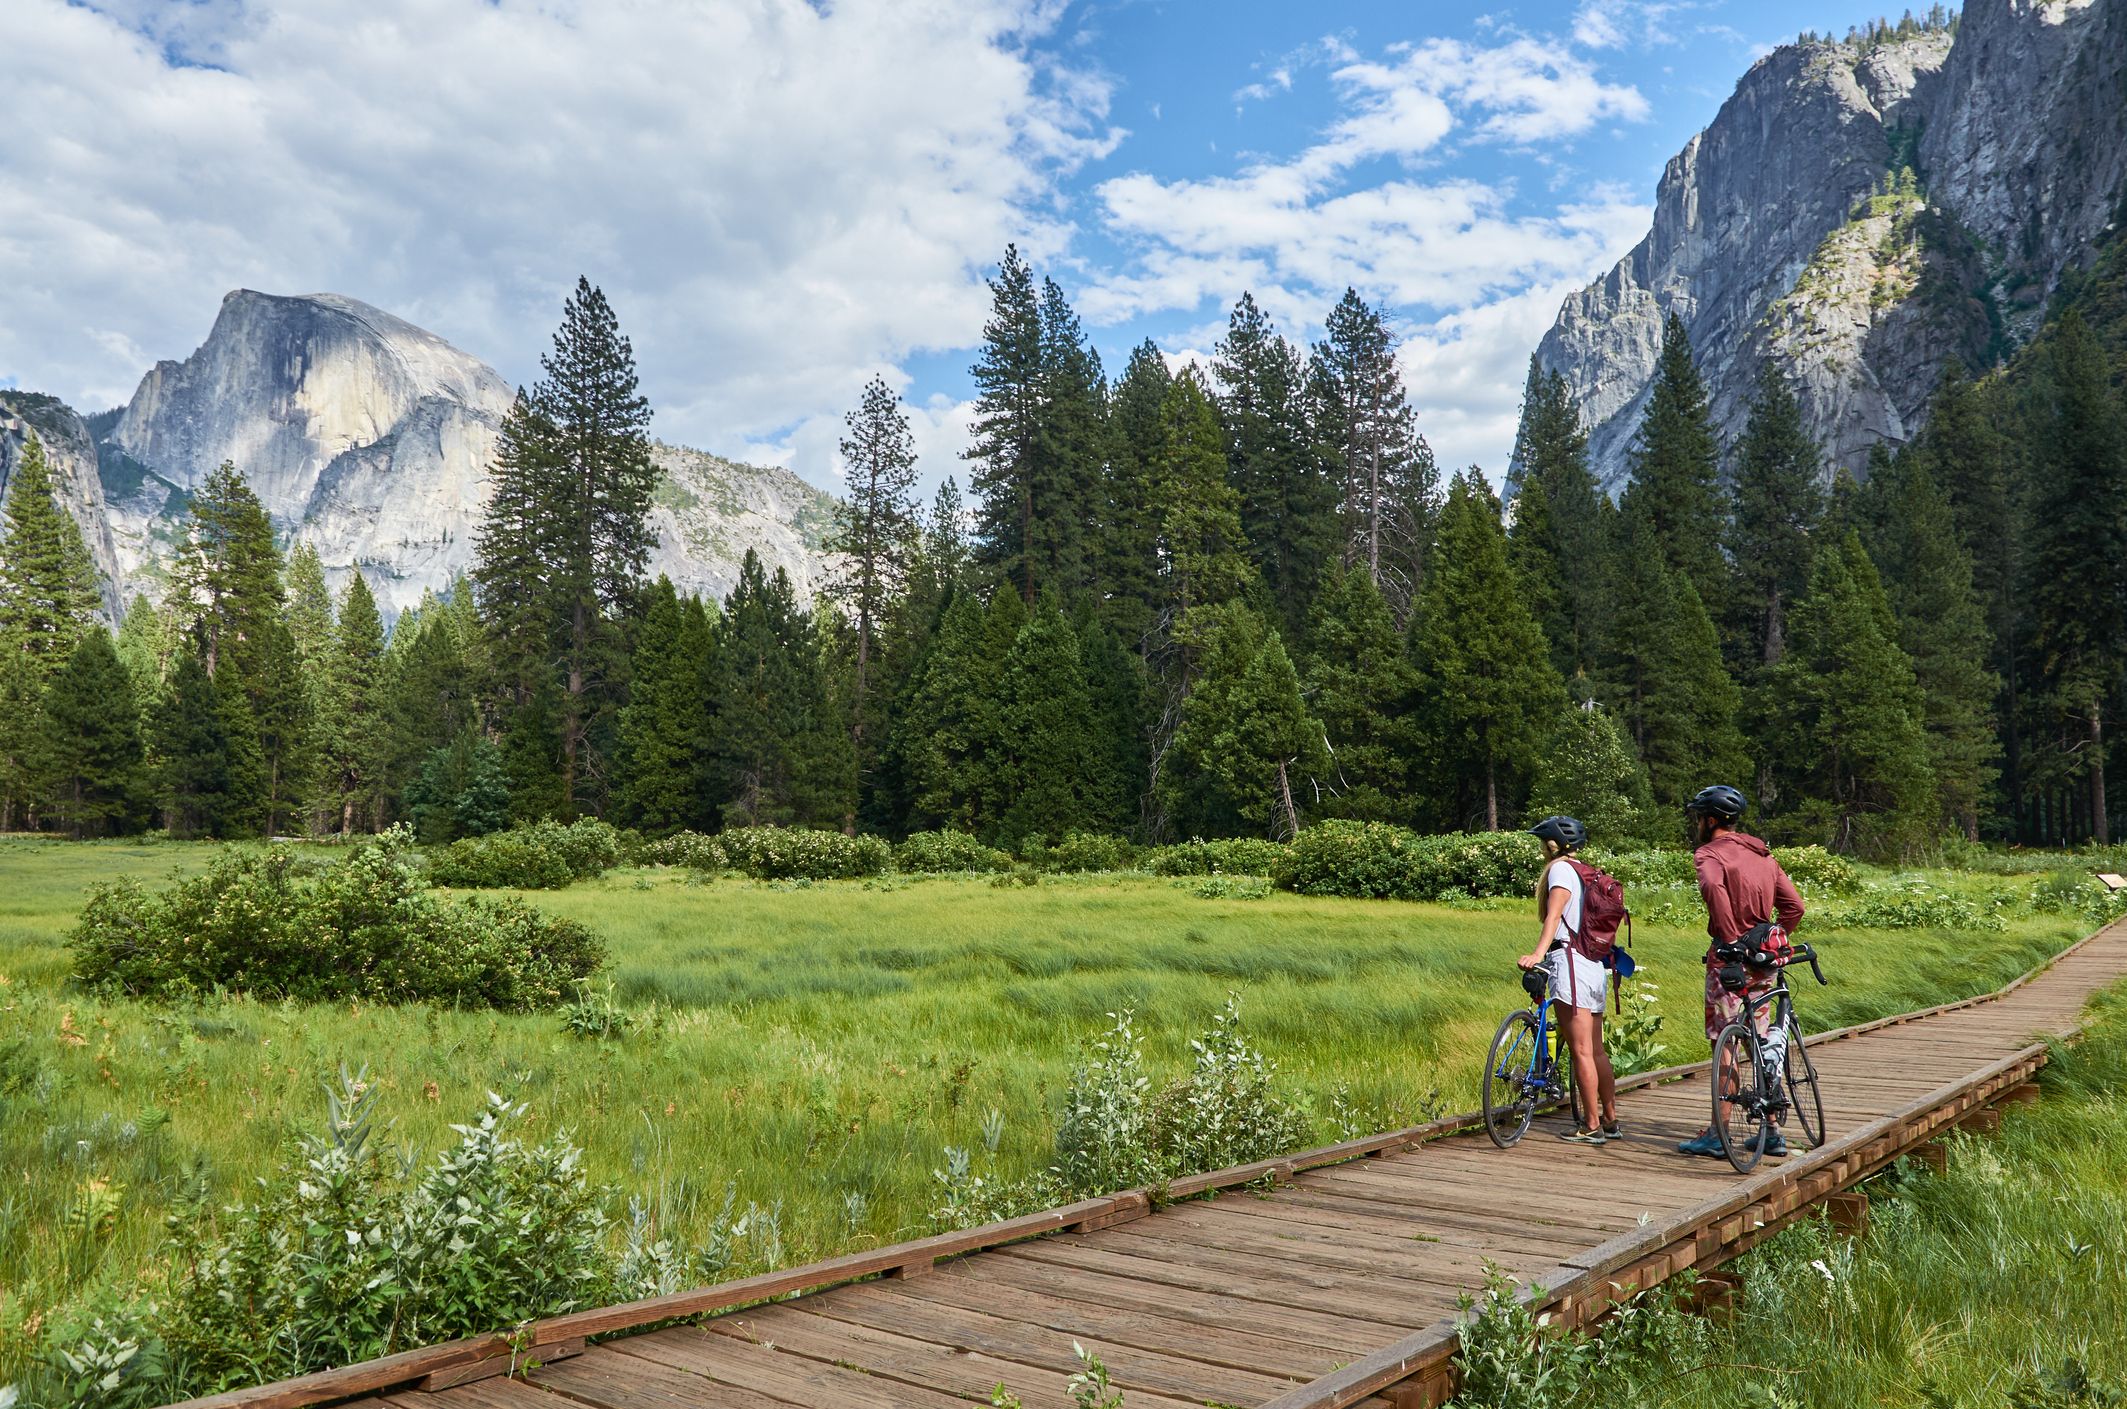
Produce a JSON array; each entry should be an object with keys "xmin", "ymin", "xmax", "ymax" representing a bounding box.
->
[{"xmin": 0, "ymin": 841, "xmax": 2082, "ymax": 1383}]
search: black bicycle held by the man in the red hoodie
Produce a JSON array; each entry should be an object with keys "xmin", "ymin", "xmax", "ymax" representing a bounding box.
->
[{"xmin": 1708, "ymin": 945, "xmax": 1825, "ymax": 1175}]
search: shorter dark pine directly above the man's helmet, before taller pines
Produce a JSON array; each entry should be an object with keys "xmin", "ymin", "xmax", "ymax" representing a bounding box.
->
[{"xmin": 1604, "ymin": 498, "xmax": 1746, "ymax": 809}]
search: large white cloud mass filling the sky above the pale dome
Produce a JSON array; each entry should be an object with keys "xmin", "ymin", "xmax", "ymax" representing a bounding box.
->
[{"xmin": 0, "ymin": 0, "xmax": 1119, "ymax": 489}]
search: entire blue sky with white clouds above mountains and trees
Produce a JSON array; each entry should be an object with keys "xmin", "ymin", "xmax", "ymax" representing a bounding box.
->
[{"xmin": 0, "ymin": 0, "xmax": 1876, "ymax": 495}]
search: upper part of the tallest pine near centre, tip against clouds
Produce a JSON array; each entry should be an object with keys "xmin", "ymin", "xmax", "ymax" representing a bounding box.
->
[{"xmin": 966, "ymin": 245, "xmax": 1057, "ymax": 600}]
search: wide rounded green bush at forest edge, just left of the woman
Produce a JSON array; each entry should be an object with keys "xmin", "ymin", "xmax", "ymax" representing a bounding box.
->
[{"xmin": 1276, "ymin": 822, "xmax": 1544, "ymax": 900}]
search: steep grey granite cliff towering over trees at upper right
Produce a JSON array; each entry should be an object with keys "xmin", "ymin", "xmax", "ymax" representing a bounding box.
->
[{"xmin": 1538, "ymin": 0, "xmax": 2127, "ymax": 490}]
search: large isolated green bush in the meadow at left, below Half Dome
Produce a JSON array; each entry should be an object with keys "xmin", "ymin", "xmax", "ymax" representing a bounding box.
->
[{"xmin": 68, "ymin": 826, "xmax": 606, "ymax": 1011}]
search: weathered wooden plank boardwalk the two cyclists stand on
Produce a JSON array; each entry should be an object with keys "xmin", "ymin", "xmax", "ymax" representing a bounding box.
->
[{"xmin": 178, "ymin": 922, "xmax": 2127, "ymax": 1409}]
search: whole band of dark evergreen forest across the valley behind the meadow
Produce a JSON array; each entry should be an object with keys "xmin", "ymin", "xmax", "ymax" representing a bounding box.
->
[{"xmin": 0, "ymin": 241, "xmax": 2127, "ymax": 858}]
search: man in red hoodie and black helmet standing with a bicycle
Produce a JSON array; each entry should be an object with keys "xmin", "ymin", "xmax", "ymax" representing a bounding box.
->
[{"xmin": 1676, "ymin": 783, "xmax": 1802, "ymax": 1158}]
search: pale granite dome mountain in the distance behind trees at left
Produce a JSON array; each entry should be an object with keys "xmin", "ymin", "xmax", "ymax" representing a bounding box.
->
[{"xmin": 0, "ymin": 289, "xmax": 832, "ymax": 613}]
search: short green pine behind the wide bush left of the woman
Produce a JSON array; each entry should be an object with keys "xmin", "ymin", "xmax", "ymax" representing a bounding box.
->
[{"xmin": 1304, "ymin": 562, "xmax": 1419, "ymax": 824}]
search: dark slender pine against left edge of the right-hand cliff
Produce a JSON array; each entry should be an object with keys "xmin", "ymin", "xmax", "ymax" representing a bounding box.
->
[{"xmin": 1506, "ymin": 355, "xmax": 1614, "ymax": 698}]
